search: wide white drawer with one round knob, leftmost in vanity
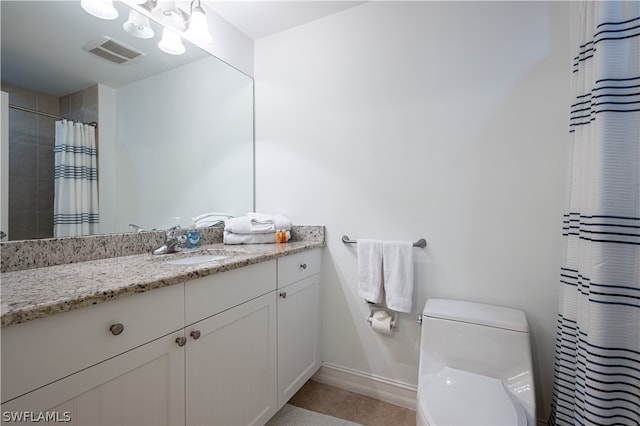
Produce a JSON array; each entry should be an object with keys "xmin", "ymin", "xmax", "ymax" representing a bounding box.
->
[{"xmin": 2, "ymin": 284, "xmax": 184, "ymax": 402}]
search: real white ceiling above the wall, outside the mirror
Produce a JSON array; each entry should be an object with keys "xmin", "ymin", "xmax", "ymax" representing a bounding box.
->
[{"xmin": 204, "ymin": 0, "xmax": 365, "ymax": 40}]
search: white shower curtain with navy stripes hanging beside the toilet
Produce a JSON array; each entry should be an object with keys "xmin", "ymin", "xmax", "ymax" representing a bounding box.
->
[{"xmin": 549, "ymin": 1, "xmax": 640, "ymax": 425}]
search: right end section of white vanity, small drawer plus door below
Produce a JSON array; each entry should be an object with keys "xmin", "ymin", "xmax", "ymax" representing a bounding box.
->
[{"xmin": 278, "ymin": 249, "xmax": 322, "ymax": 409}]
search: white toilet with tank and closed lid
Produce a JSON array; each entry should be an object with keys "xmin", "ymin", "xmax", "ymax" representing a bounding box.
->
[{"xmin": 416, "ymin": 299, "xmax": 536, "ymax": 426}]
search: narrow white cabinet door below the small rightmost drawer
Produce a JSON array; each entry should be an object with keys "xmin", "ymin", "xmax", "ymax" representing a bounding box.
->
[{"xmin": 278, "ymin": 274, "xmax": 322, "ymax": 409}]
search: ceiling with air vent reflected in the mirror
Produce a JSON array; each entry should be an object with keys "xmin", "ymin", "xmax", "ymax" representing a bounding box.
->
[{"xmin": 0, "ymin": 0, "xmax": 207, "ymax": 96}]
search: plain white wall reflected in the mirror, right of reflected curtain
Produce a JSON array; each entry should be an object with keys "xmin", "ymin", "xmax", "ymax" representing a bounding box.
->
[{"xmin": 113, "ymin": 57, "xmax": 253, "ymax": 232}]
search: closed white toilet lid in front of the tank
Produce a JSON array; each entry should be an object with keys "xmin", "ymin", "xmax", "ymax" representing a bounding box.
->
[{"xmin": 419, "ymin": 367, "xmax": 527, "ymax": 426}]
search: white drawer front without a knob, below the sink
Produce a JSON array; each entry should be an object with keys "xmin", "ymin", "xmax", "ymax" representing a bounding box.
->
[{"xmin": 185, "ymin": 260, "xmax": 276, "ymax": 325}]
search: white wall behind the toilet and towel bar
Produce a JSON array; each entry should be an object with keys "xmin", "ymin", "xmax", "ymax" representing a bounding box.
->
[{"xmin": 254, "ymin": 1, "xmax": 570, "ymax": 416}]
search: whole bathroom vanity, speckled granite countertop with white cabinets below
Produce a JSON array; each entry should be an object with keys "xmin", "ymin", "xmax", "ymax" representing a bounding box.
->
[{"xmin": 2, "ymin": 230, "xmax": 324, "ymax": 425}]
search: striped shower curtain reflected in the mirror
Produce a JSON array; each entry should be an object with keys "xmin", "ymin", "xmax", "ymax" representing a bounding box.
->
[{"xmin": 53, "ymin": 120, "xmax": 99, "ymax": 237}]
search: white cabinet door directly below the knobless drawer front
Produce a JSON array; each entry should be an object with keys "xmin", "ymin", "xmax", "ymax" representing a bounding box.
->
[{"xmin": 186, "ymin": 291, "xmax": 277, "ymax": 425}]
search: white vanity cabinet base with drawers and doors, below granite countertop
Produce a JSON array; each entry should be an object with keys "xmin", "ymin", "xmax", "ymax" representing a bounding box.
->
[{"xmin": 1, "ymin": 249, "xmax": 321, "ymax": 425}]
